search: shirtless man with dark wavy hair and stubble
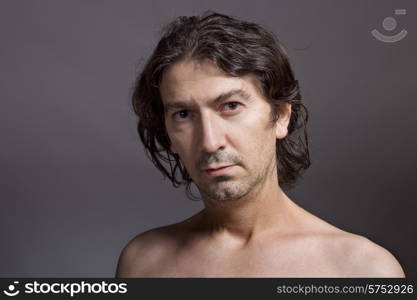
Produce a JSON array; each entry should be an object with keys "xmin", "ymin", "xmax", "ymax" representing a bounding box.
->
[{"xmin": 116, "ymin": 13, "xmax": 404, "ymax": 277}]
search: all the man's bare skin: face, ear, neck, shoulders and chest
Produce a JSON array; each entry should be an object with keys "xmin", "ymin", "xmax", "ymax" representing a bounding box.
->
[{"xmin": 116, "ymin": 61, "xmax": 405, "ymax": 277}]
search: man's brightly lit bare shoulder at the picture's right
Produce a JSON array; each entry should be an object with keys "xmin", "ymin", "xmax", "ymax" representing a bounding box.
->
[{"xmin": 324, "ymin": 230, "xmax": 405, "ymax": 277}]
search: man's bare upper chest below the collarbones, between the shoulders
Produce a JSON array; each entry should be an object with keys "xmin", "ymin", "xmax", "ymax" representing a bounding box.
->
[{"xmin": 143, "ymin": 240, "xmax": 343, "ymax": 277}]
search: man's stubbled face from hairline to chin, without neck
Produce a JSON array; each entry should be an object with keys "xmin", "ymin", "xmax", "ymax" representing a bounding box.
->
[{"xmin": 160, "ymin": 60, "xmax": 286, "ymax": 201}]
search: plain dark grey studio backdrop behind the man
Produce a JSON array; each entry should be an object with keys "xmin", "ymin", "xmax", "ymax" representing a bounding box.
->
[{"xmin": 0, "ymin": 0, "xmax": 417, "ymax": 277}]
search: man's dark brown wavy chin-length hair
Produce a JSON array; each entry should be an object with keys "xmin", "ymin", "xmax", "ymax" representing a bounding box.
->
[{"xmin": 132, "ymin": 12, "xmax": 310, "ymax": 198}]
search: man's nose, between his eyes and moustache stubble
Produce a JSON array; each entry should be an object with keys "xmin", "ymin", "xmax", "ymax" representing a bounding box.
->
[{"xmin": 198, "ymin": 113, "xmax": 226, "ymax": 153}]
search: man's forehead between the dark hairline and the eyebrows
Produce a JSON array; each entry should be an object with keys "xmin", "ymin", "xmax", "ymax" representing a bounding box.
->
[{"xmin": 160, "ymin": 60, "xmax": 262, "ymax": 103}]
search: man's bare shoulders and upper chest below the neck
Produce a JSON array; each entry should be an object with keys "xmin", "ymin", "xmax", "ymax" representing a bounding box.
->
[{"xmin": 116, "ymin": 203, "xmax": 405, "ymax": 277}]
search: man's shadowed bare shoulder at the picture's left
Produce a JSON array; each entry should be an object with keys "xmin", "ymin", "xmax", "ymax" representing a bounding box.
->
[{"xmin": 116, "ymin": 225, "xmax": 180, "ymax": 277}]
